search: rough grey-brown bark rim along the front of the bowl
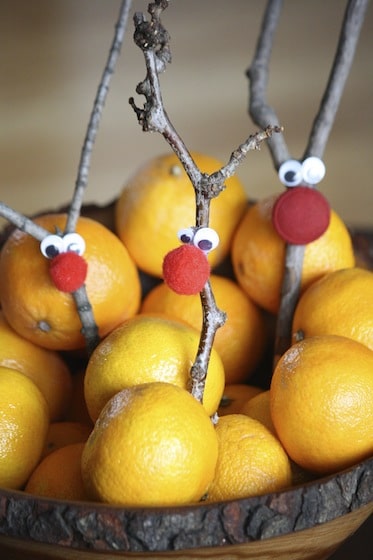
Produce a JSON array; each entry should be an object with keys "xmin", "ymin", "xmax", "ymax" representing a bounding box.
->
[{"xmin": 0, "ymin": 456, "xmax": 373, "ymax": 553}]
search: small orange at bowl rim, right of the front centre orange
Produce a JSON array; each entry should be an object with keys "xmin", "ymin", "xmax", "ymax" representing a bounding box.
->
[{"xmin": 207, "ymin": 414, "xmax": 291, "ymax": 501}]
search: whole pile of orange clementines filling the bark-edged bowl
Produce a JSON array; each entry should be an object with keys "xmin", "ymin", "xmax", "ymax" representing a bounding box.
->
[{"xmin": 0, "ymin": 153, "xmax": 373, "ymax": 507}]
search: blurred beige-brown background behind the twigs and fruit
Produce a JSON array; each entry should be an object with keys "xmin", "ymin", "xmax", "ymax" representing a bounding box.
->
[{"xmin": 0, "ymin": 0, "xmax": 373, "ymax": 230}]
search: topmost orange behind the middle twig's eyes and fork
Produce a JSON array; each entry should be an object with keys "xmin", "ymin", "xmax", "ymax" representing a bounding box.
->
[{"xmin": 116, "ymin": 153, "xmax": 247, "ymax": 277}]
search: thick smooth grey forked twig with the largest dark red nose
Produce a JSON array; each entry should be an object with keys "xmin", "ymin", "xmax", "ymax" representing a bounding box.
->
[{"xmin": 247, "ymin": 0, "xmax": 368, "ymax": 364}]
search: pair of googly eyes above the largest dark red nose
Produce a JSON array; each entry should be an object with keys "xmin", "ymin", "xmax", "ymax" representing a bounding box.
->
[{"xmin": 278, "ymin": 156, "xmax": 325, "ymax": 187}]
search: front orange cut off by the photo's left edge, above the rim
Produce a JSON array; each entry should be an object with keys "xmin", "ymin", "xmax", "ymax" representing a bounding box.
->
[{"xmin": 0, "ymin": 366, "xmax": 49, "ymax": 489}]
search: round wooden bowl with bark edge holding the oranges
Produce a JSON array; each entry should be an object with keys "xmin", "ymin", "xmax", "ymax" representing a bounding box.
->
[{"xmin": 0, "ymin": 204, "xmax": 373, "ymax": 560}]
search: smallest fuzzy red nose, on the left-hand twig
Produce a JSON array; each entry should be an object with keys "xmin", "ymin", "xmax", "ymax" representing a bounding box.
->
[{"xmin": 49, "ymin": 251, "xmax": 88, "ymax": 292}]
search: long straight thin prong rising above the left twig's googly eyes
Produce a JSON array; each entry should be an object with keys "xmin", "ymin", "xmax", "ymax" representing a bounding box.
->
[{"xmin": 65, "ymin": 0, "xmax": 132, "ymax": 233}]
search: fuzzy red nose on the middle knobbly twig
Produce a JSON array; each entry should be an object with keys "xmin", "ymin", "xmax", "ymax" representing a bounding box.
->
[{"xmin": 163, "ymin": 245, "xmax": 210, "ymax": 295}]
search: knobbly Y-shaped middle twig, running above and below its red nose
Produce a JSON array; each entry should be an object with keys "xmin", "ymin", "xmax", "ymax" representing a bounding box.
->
[{"xmin": 129, "ymin": 0, "xmax": 280, "ymax": 401}]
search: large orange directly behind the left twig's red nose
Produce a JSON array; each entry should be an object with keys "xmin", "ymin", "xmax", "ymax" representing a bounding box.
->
[{"xmin": 0, "ymin": 214, "xmax": 141, "ymax": 350}]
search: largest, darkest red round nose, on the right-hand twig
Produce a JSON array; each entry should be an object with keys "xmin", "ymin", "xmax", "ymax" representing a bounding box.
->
[{"xmin": 272, "ymin": 187, "xmax": 330, "ymax": 245}]
